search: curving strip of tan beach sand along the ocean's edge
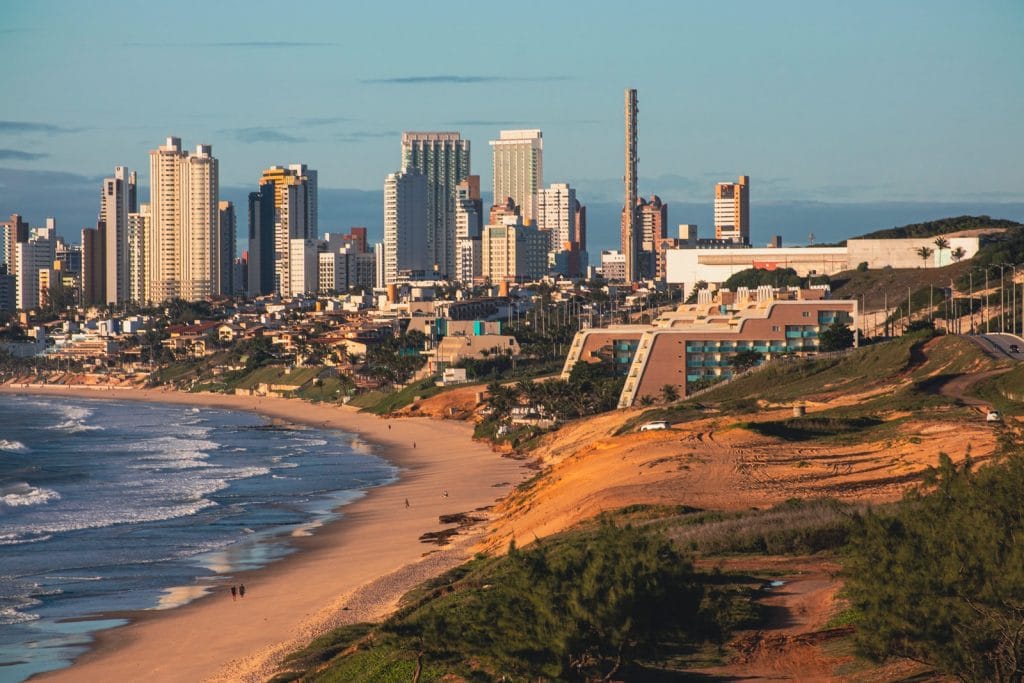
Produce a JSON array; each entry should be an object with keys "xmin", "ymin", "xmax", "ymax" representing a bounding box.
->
[{"xmin": 0, "ymin": 386, "xmax": 528, "ymax": 683}]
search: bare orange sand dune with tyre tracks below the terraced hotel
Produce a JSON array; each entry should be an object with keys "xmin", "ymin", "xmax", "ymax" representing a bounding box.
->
[{"xmin": 479, "ymin": 411, "xmax": 995, "ymax": 548}]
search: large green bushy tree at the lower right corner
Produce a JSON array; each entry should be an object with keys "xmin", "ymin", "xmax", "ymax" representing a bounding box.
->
[{"xmin": 845, "ymin": 453, "xmax": 1024, "ymax": 683}]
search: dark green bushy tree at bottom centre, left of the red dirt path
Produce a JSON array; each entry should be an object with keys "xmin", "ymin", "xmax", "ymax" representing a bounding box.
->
[{"xmin": 403, "ymin": 520, "xmax": 703, "ymax": 681}]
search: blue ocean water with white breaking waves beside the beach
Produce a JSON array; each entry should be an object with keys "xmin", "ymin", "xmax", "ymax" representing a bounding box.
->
[{"xmin": 0, "ymin": 394, "xmax": 396, "ymax": 683}]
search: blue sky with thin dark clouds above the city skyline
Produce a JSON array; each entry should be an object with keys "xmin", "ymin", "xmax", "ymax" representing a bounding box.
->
[{"xmin": 0, "ymin": 0, "xmax": 1024, "ymax": 252}]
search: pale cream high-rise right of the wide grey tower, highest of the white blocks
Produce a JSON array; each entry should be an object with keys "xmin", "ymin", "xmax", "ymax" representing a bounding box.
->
[{"xmin": 490, "ymin": 129, "xmax": 544, "ymax": 220}]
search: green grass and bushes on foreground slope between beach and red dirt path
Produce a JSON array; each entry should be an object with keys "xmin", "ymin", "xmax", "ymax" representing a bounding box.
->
[{"xmin": 275, "ymin": 519, "xmax": 770, "ymax": 682}]
